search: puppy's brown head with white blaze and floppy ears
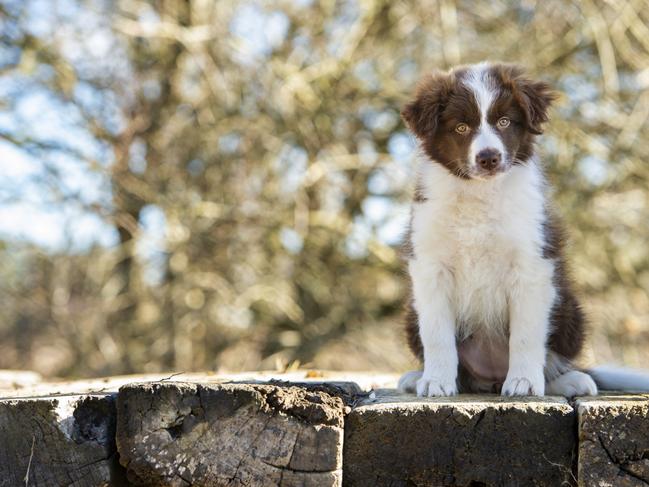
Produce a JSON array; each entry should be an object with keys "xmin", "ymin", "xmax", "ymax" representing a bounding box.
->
[{"xmin": 401, "ymin": 63, "xmax": 555, "ymax": 179}]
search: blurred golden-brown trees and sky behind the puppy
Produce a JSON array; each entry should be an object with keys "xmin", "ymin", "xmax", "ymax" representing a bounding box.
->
[{"xmin": 0, "ymin": 0, "xmax": 649, "ymax": 376}]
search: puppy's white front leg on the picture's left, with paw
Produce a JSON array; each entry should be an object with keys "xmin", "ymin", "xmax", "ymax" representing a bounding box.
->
[{"xmin": 409, "ymin": 259, "xmax": 458, "ymax": 396}]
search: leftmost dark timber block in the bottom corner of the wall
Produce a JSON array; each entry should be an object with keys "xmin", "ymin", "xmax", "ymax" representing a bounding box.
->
[{"xmin": 0, "ymin": 395, "xmax": 124, "ymax": 487}]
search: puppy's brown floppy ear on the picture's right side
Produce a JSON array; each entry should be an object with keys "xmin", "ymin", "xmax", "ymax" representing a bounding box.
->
[{"xmin": 494, "ymin": 64, "xmax": 557, "ymax": 135}]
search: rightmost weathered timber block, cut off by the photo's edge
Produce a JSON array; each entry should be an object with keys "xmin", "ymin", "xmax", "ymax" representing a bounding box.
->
[{"xmin": 576, "ymin": 395, "xmax": 649, "ymax": 487}]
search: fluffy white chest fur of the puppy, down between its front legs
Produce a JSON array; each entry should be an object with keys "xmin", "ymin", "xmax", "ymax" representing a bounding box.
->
[{"xmin": 411, "ymin": 166, "xmax": 544, "ymax": 338}]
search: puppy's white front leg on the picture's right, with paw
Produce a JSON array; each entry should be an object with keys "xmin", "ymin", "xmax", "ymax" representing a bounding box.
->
[{"xmin": 502, "ymin": 258, "xmax": 556, "ymax": 396}]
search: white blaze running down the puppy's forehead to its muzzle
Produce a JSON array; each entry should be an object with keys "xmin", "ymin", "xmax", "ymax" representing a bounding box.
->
[{"xmin": 464, "ymin": 63, "xmax": 507, "ymax": 169}]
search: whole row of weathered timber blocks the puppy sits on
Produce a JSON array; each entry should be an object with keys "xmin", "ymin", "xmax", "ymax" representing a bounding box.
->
[{"xmin": 0, "ymin": 371, "xmax": 649, "ymax": 487}]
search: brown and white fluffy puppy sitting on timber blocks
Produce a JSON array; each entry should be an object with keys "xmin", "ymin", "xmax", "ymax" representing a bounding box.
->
[{"xmin": 399, "ymin": 63, "xmax": 649, "ymax": 396}]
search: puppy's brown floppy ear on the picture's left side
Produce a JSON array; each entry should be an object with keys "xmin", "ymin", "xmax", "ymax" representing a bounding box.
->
[{"xmin": 401, "ymin": 72, "xmax": 453, "ymax": 138}]
